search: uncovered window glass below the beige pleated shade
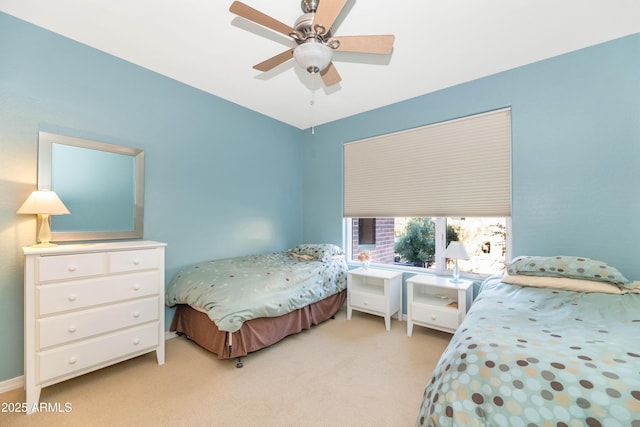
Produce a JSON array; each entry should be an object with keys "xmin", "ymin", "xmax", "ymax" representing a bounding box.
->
[{"xmin": 347, "ymin": 217, "xmax": 510, "ymax": 278}]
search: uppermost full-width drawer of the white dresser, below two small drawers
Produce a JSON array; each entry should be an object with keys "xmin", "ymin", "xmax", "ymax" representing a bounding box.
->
[{"xmin": 36, "ymin": 271, "xmax": 160, "ymax": 315}]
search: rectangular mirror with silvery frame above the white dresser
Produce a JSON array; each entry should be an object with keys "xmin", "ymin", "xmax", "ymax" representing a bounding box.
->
[{"xmin": 38, "ymin": 132, "xmax": 144, "ymax": 242}]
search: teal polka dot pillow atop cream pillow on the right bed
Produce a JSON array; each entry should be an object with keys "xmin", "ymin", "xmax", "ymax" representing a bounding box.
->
[{"xmin": 507, "ymin": 256, "xmax": 633, "ymax": 288}]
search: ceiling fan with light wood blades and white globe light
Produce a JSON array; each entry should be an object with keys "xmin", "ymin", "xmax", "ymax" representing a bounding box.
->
[{"xmin": 229, "ymin": 0, "xmax": 395, "ymax": 86}]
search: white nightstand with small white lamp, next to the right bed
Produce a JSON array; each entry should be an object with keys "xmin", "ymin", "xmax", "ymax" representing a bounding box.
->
[{"xmin": 407, "ymin": 275, "xmax": 473, "ymax": 336}]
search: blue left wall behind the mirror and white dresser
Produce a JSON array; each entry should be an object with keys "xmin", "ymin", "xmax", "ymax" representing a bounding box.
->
[{"xmin": 0, "ymin": 13, "xmax": 303, "ymax": 381}]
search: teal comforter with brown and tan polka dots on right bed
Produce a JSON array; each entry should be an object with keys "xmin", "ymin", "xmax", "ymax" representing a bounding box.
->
[{"xmin": 416, "ymin": 278, "xmax": 640, "ymax": 427}]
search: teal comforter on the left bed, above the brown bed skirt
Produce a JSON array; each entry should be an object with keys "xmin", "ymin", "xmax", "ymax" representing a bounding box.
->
[{"xmin": 166, "ymin": 251, "xmax": 347, "ymax": 332}]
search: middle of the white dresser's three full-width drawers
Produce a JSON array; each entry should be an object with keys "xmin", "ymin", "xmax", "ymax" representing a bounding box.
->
[{"xmin": 37, "ymin": 297, "xmax": 158, "ymax": 349}]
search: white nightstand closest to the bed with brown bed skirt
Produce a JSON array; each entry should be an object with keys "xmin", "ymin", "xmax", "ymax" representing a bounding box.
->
[{"xmin": 347, "ymin": 268, "xmax": 402, "ymax": 331}]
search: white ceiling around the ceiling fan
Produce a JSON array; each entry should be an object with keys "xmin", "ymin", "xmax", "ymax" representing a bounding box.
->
[{"xmin": 0, "ymin": 0, "xmax": 640, "ymax": 129}]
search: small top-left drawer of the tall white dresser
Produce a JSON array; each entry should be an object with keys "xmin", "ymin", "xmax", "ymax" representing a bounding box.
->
[{"xmin": 36, "ymin": 253, "xmax": 107, "ymax": 282}]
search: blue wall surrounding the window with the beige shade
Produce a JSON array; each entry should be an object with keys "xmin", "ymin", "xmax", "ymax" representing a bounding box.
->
[{"xmin": 303, "ymin": 34, "xmax": 640, "ymax": 280}]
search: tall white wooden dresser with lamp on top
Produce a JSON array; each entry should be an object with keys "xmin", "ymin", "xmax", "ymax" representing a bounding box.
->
[{"xmin": 23, "ymin": 241, "xmax": 166, "ymax": 413}]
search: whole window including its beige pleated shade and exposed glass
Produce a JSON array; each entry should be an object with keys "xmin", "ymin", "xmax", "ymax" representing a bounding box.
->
[{"xmin": 343, "ymin": 108, "xmax": 511, "ymax": 276}]
